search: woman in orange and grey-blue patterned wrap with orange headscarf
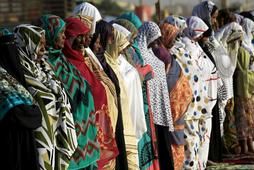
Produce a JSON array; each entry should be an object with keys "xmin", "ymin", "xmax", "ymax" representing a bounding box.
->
[{"xmin": 153, "ymin": 23, "xmax": 192, "ymax": 169}]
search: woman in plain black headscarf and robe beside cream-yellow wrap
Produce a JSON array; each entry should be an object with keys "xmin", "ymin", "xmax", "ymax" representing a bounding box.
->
[{"xmin": 90, "ymin": 20, "xmax": 128, "ymax": 170}]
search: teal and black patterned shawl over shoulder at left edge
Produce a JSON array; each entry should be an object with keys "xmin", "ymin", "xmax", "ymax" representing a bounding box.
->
[{"xmin": 0, "ymin": 67, "xmax": 33, "ymax": 120}]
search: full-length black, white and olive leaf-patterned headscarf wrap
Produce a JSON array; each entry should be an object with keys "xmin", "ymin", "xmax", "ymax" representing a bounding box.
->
[{"xmin": 14, "ymin": 24, "xmax": 77, "ymax": 169}]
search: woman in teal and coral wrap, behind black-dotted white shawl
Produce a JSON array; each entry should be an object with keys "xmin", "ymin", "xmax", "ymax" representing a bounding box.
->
[{"xmin": 110, "ymin": 15, "xmax": 159, "ymax": 169}]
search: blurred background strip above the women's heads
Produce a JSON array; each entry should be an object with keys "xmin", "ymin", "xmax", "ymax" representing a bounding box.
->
[{"xmin": 0, "ymin": 0, "xmax": 254, "ymax": 28}]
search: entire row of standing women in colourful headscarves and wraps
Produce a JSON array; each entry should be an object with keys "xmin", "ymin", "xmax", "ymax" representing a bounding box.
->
[{"xmin": 0, "ymin": 1, "xmax": 254, "ymax": 170}]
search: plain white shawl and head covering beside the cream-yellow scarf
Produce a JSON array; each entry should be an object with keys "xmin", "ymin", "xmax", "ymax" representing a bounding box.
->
[{"xmin": 113, "ymin": 24, "xmax": 147, "ymax": 139}]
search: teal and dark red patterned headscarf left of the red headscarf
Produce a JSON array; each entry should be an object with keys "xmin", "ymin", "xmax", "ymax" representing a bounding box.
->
[{"xmin": 40, "ymin": 14, "xmax": 65, "ymax": 47}]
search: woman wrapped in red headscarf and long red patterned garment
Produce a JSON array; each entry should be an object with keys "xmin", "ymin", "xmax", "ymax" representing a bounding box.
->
[{"xmin": 63, "ymin": 18, "xmax": 118, "ymax": 169}]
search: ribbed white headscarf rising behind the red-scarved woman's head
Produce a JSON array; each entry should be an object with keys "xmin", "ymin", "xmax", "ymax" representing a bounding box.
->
[{"xmin": 73, "ymin": 2, "xmax": 102, "ymax": 34}]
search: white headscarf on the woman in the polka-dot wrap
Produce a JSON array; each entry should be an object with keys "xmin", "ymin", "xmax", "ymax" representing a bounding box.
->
[{"xmin": 185, "ymin": 16, "xmax": 208, "ymax": 39}]
